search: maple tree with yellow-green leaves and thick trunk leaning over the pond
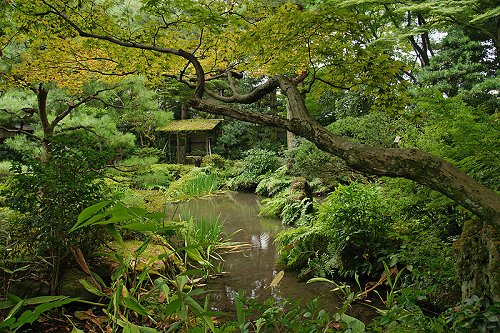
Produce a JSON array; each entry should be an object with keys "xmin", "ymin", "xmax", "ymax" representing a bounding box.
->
[{"xmin": 2, "ymin": 0, "xmax": 500, "ymax": 298}]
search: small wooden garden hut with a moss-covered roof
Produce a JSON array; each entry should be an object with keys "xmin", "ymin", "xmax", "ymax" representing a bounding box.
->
[{"xmin": 156, "ymin": 119, "xmax": 223, "ymax": 164}]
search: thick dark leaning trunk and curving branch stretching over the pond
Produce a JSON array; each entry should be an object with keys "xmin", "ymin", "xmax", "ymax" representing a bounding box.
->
[{"xmin": 44, "ymin": 1, "xmax": 500, "ymax": 224}]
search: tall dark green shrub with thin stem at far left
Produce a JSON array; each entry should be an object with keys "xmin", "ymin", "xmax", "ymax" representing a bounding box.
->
[{"xmin": 3, "ymin": 133, "xmax": 110, "ymax": 292}]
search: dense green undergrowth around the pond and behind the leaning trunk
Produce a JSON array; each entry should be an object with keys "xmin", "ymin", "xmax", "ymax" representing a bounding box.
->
[{"xmin": 0, "ymin": 88, "xmax": 500, "ymax": 332}]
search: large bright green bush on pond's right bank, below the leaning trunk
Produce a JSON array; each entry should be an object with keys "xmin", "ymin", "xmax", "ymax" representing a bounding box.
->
[{"xmin": 277, "ymin": 183, "xmax": 392, "ymax": 276}]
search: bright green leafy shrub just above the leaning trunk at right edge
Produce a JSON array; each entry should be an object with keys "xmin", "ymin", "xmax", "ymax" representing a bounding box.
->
[{"xmin": 414, "ymin": 90, "xmax": 500, "ymax": 190}]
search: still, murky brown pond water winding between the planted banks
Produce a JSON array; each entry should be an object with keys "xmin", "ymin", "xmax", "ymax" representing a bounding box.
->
[{"xmin": 164, "ymin": 192, "xmax": 371, "ymax": 320}]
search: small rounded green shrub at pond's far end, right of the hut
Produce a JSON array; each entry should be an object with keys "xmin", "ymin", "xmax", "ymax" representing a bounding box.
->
[{"xmin": 228, "ymin": 149, "xmax": 282, "ymax": 190}]
